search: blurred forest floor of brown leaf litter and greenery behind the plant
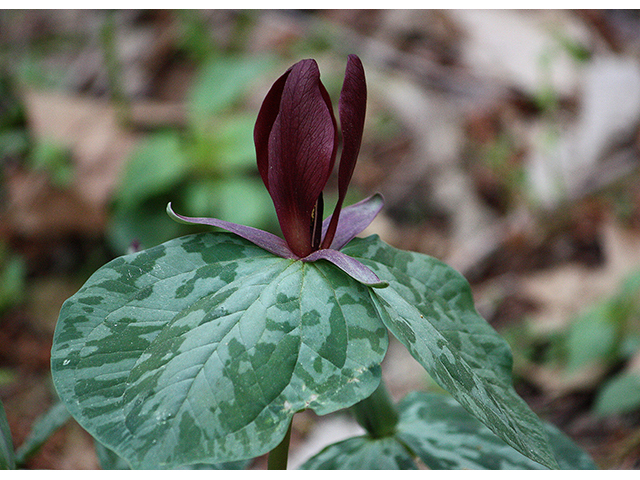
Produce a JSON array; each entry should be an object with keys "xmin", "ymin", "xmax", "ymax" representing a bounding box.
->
[{"xmin": 0, "ymin": 10, "xmax": 640, "ymax": 469}]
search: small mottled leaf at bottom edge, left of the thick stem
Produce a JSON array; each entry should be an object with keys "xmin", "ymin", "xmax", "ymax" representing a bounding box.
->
[{"xmin": 301, "ymin": 436, "xmax": 417, "ymax": 470}]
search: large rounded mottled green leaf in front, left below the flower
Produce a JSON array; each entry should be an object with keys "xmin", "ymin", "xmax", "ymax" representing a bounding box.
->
[{"xmin": 51, "ymin": 233, "xmax": 387, "ymax": 468}]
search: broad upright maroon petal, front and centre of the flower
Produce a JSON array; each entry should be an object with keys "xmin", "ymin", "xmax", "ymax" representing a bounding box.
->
[{"xmin": 266, "ymin": 60, "xmax": 337, "ymax": 257}]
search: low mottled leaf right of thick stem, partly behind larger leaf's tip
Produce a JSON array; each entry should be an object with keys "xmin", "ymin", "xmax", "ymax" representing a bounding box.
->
[{"xmin": 396, "ymin": 392, "xmax": 596, "ymax": 470}]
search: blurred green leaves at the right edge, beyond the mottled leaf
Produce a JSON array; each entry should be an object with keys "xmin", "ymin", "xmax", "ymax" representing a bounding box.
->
[{"xmin": 503, "ymin": 270, "xmax": 640, "ymax": 415}]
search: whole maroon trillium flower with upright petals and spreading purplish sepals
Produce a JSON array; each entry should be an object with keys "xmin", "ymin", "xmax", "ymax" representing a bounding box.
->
[{"xmin": 167, "ymin": 55, "xmax": 386, "ymax": 286}]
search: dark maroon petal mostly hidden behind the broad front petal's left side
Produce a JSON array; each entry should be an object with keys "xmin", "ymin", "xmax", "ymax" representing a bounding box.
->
[{"xmin": 253, "ymin": 67, "xmax": 293, "ymax": 191}]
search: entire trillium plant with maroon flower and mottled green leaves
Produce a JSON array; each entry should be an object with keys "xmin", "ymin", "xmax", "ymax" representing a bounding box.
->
[{"xmin": 51, "ymin": 55, "xmax": 594, "ymax": 469}]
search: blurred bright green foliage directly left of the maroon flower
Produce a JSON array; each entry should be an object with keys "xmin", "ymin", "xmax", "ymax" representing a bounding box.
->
[{"xmin": 108, "ymin": 55, "xmax": 276, "ymax": 253}]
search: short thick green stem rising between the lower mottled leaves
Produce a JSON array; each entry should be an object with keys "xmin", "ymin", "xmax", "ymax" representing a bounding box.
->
[{"xmin": 351, "ymin": 380, "xmax": 398, "ymax": 438}]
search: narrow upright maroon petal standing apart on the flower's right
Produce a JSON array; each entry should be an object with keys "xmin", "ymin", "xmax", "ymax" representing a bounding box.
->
[{"xmin": 322, "ymin": 55, "xmax": 367, "ymax": 248}]
